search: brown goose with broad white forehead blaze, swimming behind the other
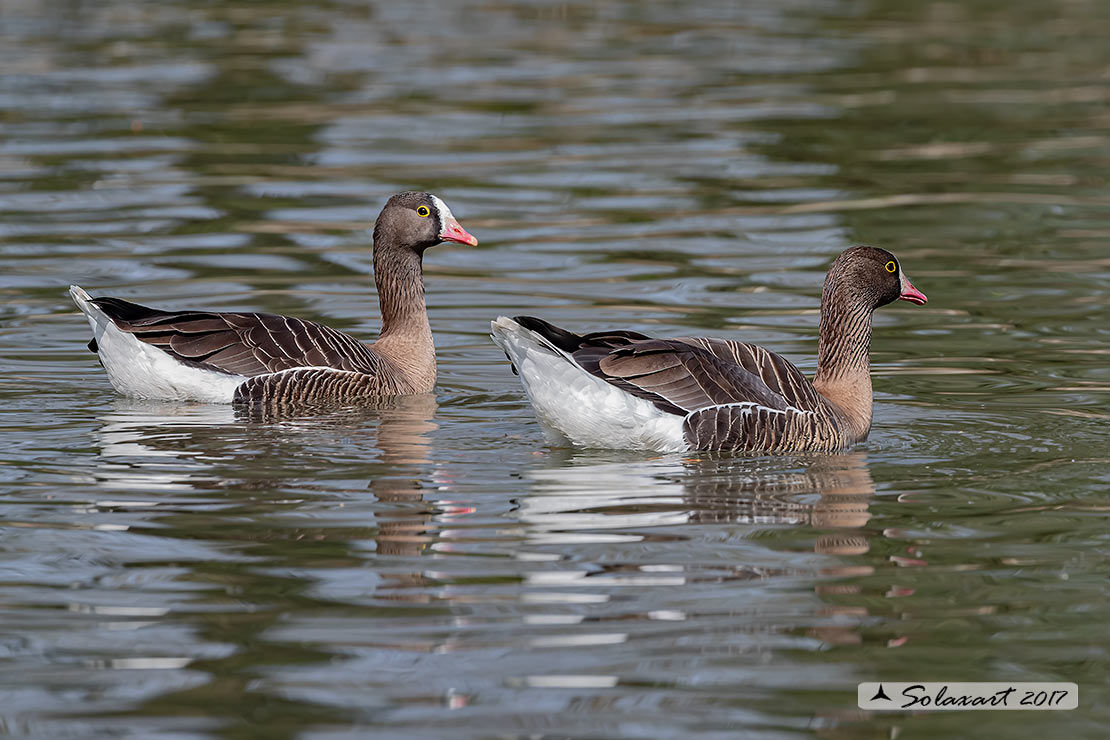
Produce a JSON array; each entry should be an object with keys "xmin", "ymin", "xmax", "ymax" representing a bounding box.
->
[{"xmin": 70, "ymin": 192, "xmax": 478, "ymax": 403}]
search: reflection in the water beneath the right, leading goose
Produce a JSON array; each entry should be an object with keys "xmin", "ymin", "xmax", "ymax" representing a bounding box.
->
[{"xmin": 516, "ymin": 452, "xmax": 899, "ymax": 645}]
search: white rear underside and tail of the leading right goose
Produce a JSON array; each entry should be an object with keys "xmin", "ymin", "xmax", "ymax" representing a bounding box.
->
[{"xmin": 492, "ymin": 316, "xmax": 687, "ymax": 453}]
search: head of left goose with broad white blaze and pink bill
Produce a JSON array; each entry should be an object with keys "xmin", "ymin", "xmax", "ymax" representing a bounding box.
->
[{"xmin": 374, "ymin": 191, "xmax": 478, "ymax": 254}]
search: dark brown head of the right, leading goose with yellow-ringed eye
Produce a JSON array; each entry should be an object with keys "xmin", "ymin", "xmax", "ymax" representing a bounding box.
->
[{"xmin": 825, "ymin": 246, "xmax": 928, "ymax": 311}]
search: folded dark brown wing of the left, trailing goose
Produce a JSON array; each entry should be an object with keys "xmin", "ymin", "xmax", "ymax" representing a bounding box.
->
[{"xmin": 92, "ymin": 298, "xmax": 381, "ymax": 377}]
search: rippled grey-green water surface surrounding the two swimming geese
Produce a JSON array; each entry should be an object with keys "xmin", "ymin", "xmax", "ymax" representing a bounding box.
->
[{"xmin": 0, "ymin": 0, "xmax": 1110, "ymax": 739}]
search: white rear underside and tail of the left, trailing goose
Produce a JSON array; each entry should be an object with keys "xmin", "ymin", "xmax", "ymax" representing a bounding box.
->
[{"xmin": 70, "ymin": 285, "xmax": 246, "ymax": 404}]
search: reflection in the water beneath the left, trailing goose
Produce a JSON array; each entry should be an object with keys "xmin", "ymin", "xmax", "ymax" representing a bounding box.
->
[{"xmin": 87, "ymin": 394, "xmax": 444, "ymax": 572}]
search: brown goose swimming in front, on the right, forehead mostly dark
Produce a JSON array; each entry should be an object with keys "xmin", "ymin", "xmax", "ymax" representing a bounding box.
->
[{"xmin": 493, "ymin": 246, "xmax": 926, "ymax": 452}]
